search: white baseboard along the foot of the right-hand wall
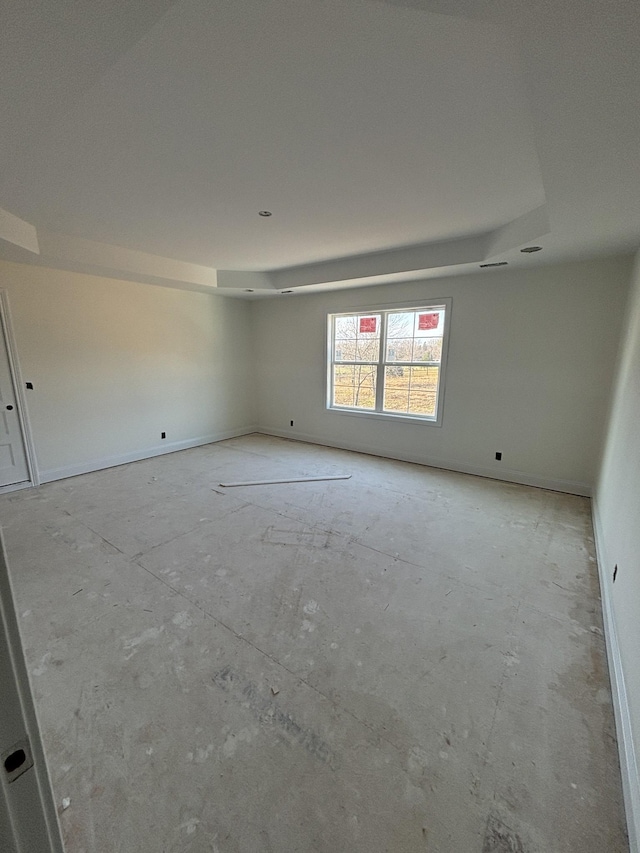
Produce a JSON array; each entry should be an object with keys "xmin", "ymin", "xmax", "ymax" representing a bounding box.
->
[{"xmin": 591, "ymin": 499, "xmax": 640, "ymax": 853}]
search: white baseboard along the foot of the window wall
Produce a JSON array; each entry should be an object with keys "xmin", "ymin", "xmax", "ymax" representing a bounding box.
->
[{"xmin": 256, "ymin": 427, "xmax": 591, "ymax": 497}]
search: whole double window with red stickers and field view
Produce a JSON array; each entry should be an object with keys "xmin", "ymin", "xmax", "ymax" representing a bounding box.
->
[{"xmin": 327, "ymin": 300, "xmax": 451, "ymax": 424}]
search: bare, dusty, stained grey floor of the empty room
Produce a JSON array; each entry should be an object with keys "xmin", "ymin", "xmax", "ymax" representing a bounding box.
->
[{"xmin": 0, "ymin": 435, "xmax": 628, "ymax": 853}]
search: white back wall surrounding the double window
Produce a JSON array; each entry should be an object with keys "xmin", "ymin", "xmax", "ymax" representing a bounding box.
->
[{"xmin": 253, "ymin": 253, "xmax": 631, "ymax": 493}]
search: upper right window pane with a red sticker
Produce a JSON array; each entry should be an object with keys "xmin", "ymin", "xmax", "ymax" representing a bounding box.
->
[{"xmin": 385, "ymin": 309, "xmax": 444, "ymax": 363}]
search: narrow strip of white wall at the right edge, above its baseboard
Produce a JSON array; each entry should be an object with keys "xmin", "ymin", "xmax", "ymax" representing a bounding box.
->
[{"xmin": 594, "ymin": 253, "xmax": 640, "ymax": 850}]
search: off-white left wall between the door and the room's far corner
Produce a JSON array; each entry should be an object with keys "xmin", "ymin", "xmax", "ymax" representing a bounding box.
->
[{"xmin": 0, "ymin": 262, "xmax": 255, "ymax": 479}]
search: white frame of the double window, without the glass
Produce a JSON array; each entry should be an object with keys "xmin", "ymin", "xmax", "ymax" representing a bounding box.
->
[{"xmin": 325, "ymin": 297, "xmax": 452, "ymax": 427}]
